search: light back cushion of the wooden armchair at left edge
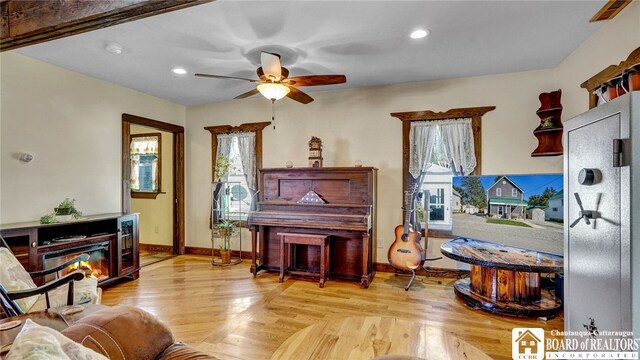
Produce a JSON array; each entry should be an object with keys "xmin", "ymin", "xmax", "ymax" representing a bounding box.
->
[{"xmin": 0, "ymin": 246, "xmax": 38, "ymax": 313}]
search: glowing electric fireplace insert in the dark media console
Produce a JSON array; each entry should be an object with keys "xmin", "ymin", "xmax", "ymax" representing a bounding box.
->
[{"xmin": 43, "ymin": 241, "xmax": 111, "ymax": 281}]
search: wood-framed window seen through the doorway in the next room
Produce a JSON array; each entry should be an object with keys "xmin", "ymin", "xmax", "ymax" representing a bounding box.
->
[{"xmin": 129, "ymin": 133, "xmax": 162, "ymax": 199}]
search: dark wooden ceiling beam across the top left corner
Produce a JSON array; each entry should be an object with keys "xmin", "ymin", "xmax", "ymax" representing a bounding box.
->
[{"xmin": 0, "ymin": 0, "xmax": 213, "ymax": 51}]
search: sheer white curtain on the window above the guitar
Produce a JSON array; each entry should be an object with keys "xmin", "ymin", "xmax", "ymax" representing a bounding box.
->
[{"xmin": 409, "ymin": 118, "xmax": 476, "ymax": 179}]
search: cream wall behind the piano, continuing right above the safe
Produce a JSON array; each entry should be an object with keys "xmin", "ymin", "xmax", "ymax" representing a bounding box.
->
[{"xmin": 186, "ymin": 3, "xmax": 640, "ymax": 267}]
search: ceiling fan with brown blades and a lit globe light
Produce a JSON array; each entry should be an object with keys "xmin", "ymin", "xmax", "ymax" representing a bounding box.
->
[{"xmin": 195, "ymin": 51, "xmax": 347, "ymax": 104}]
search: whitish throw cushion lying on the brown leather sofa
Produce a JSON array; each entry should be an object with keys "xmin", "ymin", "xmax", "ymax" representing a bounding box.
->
[{"xmin": 6, "ymin": 319, "xmax": 107, "ymax": 360}]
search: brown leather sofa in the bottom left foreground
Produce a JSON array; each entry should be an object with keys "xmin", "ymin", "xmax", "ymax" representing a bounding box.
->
[{"xmin": 0, "ymin": 305, "xmax": 217, "ymax": 360}]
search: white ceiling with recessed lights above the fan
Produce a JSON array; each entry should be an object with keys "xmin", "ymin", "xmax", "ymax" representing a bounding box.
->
[{"xmin": 15, "ymin": 0, "xmax": 606, "ymax": 105}]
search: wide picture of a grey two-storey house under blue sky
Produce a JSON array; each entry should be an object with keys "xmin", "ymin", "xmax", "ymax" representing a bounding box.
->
[{"xmin": 449, "ymin": 174, "xmax": 564, "ymax": 254}]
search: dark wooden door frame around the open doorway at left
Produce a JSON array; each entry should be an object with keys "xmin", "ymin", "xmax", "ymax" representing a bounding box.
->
[{"xmin": 122, "ymin": 114, "xmax": 185, "ymax": 255}]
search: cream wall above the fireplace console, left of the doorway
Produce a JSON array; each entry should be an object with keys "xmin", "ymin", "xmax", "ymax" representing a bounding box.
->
[{"xmin": 0, "ymin": 52, "xmax": 185, "ymax": 224}]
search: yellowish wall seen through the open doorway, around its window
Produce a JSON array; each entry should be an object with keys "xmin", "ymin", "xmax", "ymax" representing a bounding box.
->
[{"xmin": 131, "ymin": 125, "xmax": 173, "ymax": 246}]
